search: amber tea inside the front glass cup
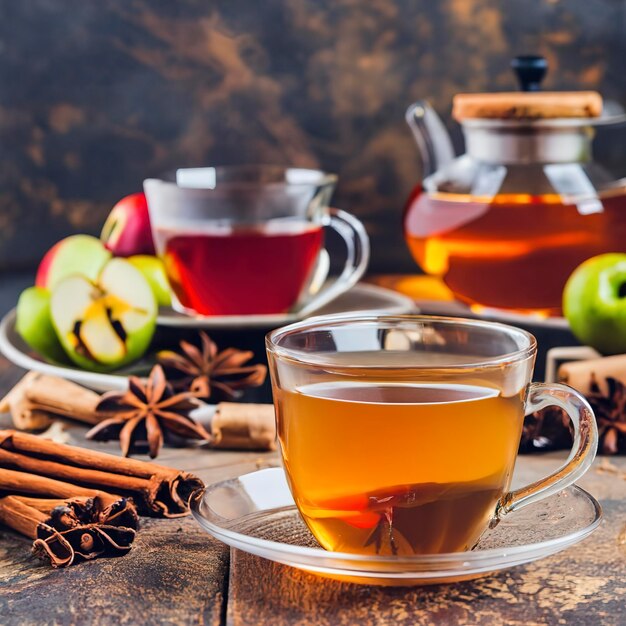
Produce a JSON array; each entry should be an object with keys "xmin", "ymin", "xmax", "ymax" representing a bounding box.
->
[{"xmin": 276, "ymin": 382, "xmax": 523, "ymax": 555}]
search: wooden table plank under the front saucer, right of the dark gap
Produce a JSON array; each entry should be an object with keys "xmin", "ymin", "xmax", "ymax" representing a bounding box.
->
[{"xmin": 227, "ymin": 455, "xmax": 626, "ymax": 626}]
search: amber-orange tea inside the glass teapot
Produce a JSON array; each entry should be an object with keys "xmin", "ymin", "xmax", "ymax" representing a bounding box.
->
[{"xmin": 404, "ymin": 184, "xmax": 626, "ymax": 315}]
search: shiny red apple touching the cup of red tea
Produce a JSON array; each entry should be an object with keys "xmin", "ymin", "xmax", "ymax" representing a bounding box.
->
[{"xmin": 100, "ymin": 193, "xmax": 155, "ymax": 256}]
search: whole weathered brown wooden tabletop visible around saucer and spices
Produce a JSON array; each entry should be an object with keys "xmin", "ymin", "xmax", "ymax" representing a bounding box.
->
[{"xmin": 0, "ymin": 357, "xmax": 626, "ymax": 626}]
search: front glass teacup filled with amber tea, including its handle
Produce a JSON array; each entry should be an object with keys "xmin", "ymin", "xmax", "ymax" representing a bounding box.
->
[{"xmin": 267, "ymin": 316, "xmax": 597, "ymax": 555}]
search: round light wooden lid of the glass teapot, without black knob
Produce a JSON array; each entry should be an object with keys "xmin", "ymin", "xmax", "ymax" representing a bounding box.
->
[{"xmin": 452, "ymin": 91, "xmax": 602, "ymax": 122}]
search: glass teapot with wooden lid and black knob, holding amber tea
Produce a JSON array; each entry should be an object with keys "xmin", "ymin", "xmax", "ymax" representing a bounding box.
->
[{"xmin": 404, "ymin": 57, "xmax": 626, "ymax": 315}]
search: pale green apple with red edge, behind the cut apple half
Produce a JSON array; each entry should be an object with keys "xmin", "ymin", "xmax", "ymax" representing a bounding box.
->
[{"xmin": 35, "ymin": 235, "xmax": 111, "ymax": 289}]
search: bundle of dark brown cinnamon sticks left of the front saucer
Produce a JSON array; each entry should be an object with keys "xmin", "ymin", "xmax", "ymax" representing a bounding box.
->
[{"xmin": 0, "ymin": 430, "xmax": 203, "ymax": 567}]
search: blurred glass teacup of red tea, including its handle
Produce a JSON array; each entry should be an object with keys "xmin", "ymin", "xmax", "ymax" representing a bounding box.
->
[{"xmin": 144, "ymin": 165, "xmax": 369, "ymax": 316}]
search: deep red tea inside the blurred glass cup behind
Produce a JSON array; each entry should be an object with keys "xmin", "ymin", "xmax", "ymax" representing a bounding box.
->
[{"xmin": 156, "ymin": 221, "xmax": 323, "ymax": 315}]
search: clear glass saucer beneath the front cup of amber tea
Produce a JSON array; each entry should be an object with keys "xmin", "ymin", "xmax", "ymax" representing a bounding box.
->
[{"xmin": 191, "ymin": 468, "xmax": 602, "ymax": 585}]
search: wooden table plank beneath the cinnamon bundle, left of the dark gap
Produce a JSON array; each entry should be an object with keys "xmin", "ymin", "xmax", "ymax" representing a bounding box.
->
[{"xmin": 0, "ymin": 518, "xmax": 228, "ymax": 626}]
